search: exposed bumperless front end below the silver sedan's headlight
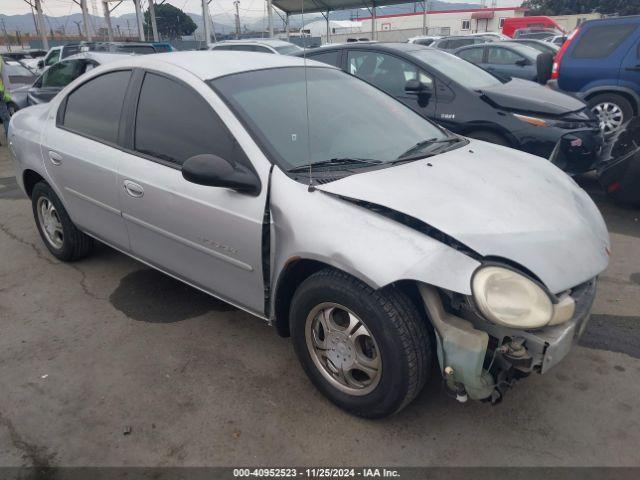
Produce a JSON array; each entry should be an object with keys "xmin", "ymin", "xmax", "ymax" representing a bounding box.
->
[{"xmin": 419, "ymin": 279, "xmax": 596, "ymax": 403}]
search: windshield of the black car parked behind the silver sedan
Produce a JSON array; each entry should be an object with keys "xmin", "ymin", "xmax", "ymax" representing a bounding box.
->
[{"xmin": 411, "ymin": 49, "xmax": 504, "ymax": 90}]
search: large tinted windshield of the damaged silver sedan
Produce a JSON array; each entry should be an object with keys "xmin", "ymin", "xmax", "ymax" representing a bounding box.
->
[{"xmin": 209, "ymin": 67, "xmax": 448, "ymax": 170}]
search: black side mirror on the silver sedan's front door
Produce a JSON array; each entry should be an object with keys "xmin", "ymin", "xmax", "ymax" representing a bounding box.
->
[{"xmin": 182, "ymin": 154, "xmax": 260, "ymax": 195}]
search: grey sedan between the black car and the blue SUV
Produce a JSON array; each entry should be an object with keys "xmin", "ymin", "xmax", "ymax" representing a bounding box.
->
[{"xmin": 453, "ymin": 42, "xmax": 551, "ymax": 82}]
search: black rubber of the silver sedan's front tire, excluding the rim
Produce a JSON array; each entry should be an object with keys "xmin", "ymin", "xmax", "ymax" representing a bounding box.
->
[{"xmin": 290, "ymin": 277, "xmax": 409, "ymax": 417}]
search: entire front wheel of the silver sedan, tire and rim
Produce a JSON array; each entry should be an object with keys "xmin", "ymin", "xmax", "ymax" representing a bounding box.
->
[{"xmin": 289, "ymin": 269, "xmax": 432, "ymax": 418}]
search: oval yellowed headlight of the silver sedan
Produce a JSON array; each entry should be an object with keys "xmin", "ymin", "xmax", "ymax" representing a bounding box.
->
[{"xmin": 471, "ymin": 266, "xmax": 553, "ymax": 329}]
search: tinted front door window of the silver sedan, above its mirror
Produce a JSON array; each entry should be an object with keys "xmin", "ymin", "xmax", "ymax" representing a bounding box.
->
[{"xmin": 134, "ymin": 73, "xmax": 243, "ymax": 165}]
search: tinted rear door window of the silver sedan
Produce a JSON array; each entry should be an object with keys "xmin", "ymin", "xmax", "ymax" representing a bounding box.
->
[{"xmin": 61, "ymin": 71, "xmax": 131, "ymax": 144}]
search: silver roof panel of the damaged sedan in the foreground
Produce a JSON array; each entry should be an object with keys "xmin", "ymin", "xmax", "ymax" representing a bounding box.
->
[{"xmin": 100, "ymin": 50, "xmax": 335, "ymax": 80}]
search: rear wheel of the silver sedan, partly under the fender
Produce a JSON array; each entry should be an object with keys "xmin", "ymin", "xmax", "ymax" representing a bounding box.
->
[{"xmin": 31, "ymin": 182, "xmax": 93, "ymax": 262}]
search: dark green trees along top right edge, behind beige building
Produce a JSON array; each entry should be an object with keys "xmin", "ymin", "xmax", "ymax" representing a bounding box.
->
[{"xmin": 522, "ymin": 0, "xmax": 640, "ymax": 15}]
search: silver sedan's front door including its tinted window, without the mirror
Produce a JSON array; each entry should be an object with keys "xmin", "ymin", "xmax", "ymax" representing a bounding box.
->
[{"xmin": 119, "ymin": 72, "xmax": 266, "ymax": 315}]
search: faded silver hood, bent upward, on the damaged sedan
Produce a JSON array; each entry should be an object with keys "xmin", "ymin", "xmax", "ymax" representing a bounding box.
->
[{"xmin": 318, "ymin": 140, "xmax": 609, "ymax": 293}]
